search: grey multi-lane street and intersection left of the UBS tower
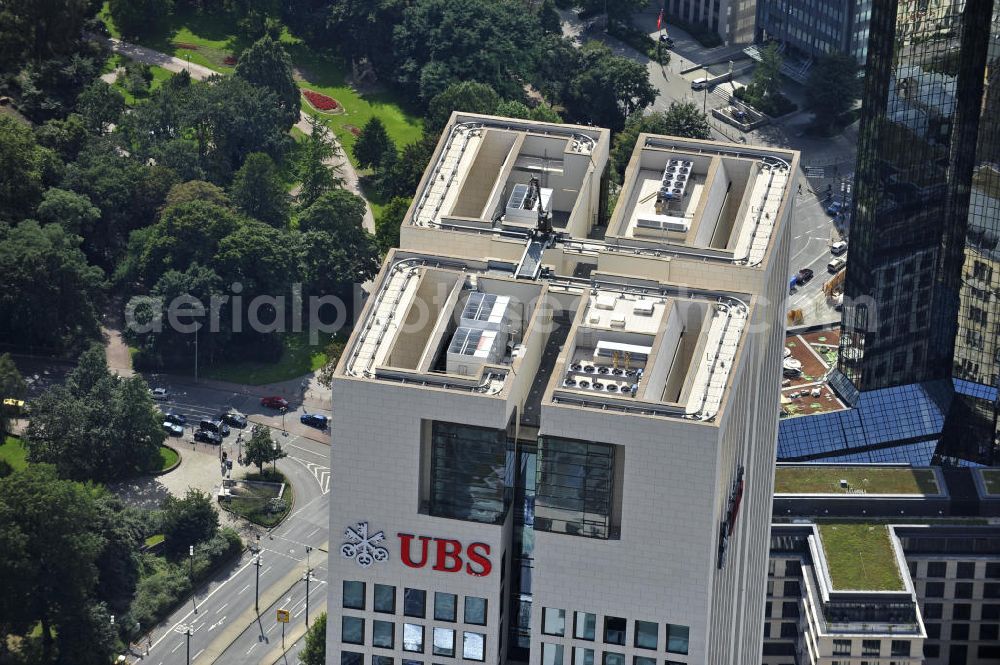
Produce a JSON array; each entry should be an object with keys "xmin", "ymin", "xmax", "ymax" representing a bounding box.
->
[{"xmin": 134, "ymin": 384, "xmax": 330, "ymax": 665}]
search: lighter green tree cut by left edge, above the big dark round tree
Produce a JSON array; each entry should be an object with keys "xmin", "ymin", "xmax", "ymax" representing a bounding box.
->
[{"xmin": 0, "ymin": 115, "xmax": 50, "ymax": 222}]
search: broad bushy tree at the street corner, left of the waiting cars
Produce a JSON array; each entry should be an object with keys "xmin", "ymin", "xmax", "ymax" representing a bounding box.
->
[{"xmin": 25, "ymin": 344, "xmax": 164, "ymax": 481}]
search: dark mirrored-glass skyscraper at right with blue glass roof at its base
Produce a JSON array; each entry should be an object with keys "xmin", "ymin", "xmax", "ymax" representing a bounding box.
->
[{"xmin": 779, "ymin": 0, "xmax": 1000, "ymax": 463}]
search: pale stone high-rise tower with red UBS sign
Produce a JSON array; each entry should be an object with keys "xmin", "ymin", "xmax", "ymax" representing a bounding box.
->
[{"xmin": 328, "ymin": 113, "xmax": 797, "ymax": 665}]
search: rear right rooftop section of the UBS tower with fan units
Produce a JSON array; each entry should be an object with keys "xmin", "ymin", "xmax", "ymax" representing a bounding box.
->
[{"xmin": 605, "ymin": 134, "xmax": 793, "ymax": 266}]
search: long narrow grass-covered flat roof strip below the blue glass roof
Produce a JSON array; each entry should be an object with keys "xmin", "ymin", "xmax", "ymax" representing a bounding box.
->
[{"xmin": 774, "ymin": 466, "xmax": 940, "ymax": 494}]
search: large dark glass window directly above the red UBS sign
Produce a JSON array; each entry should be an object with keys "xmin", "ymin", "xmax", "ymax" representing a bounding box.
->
[{"xmin": 430, "ymin": 421, "xmax": 514, "ymax": 524}]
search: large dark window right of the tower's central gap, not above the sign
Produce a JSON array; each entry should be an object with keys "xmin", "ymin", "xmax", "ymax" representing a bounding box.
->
[{"xmin": 535, "ymin": 436, "xmax": 615, "ymax": 538}]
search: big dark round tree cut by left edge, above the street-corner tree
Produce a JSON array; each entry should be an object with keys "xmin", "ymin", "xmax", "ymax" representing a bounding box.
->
[{"xmin": 0, "ymin": 220, "xmax": 104, "ymax": 351}]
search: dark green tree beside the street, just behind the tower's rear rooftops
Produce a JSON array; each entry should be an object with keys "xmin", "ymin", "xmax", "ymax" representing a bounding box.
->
[{"xmin": 565, "ymin": 42, "xmax": 656, "ymax": 131}]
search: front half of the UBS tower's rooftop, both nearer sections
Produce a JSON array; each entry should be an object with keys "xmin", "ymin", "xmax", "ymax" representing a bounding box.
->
[{"xmin": 344, "ymin": 252, "xmax": 750, "ymax": 420}]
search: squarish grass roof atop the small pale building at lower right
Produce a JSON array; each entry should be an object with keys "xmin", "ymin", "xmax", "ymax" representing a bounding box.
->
[{"xmin": 818, "ymin": 522, "xmax": 903, "ymax": 591}]
